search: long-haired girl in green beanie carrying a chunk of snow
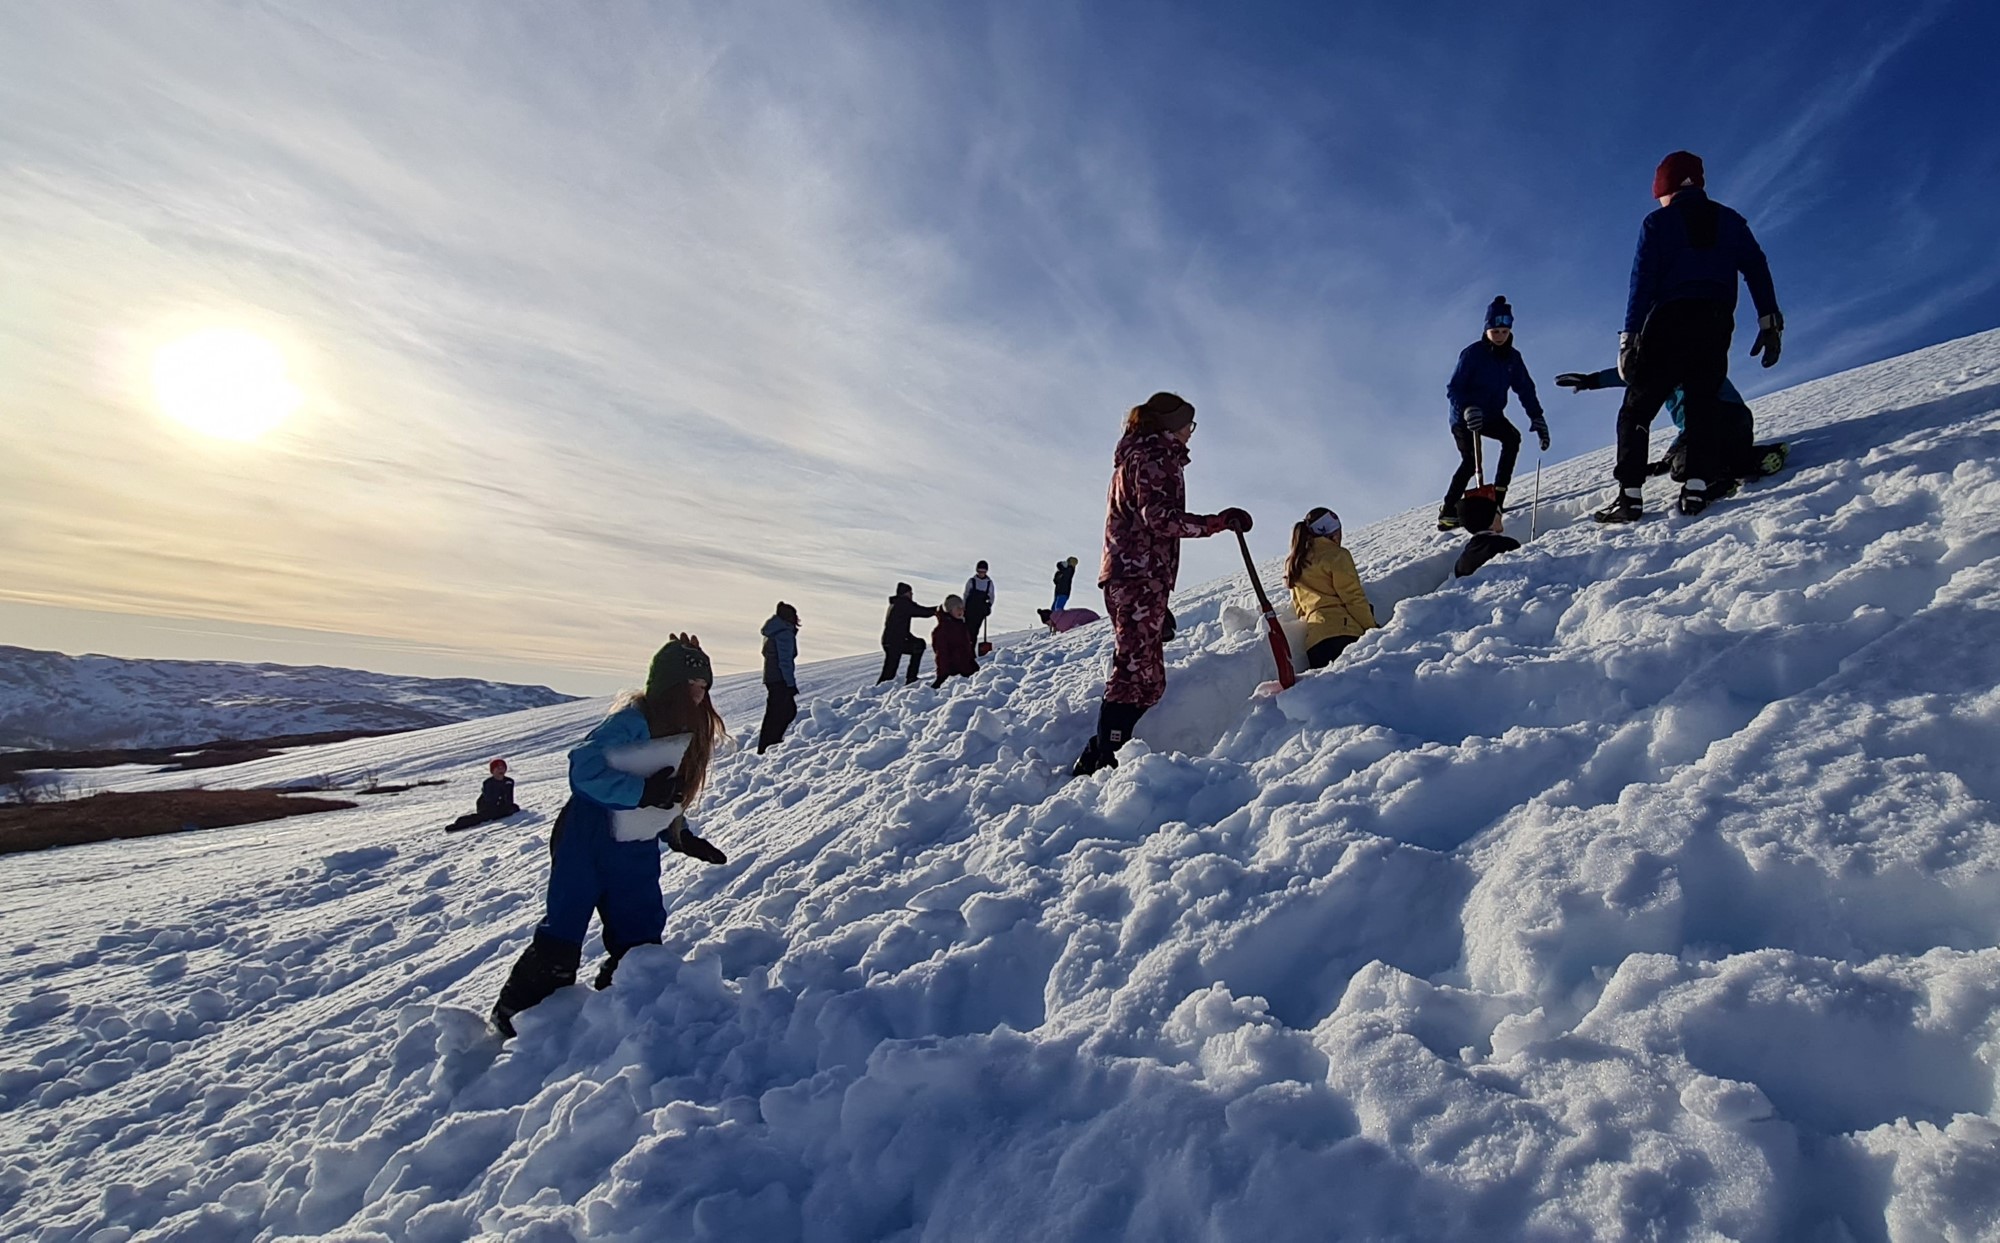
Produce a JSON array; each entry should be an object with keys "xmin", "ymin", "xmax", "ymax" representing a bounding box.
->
[{"xmin": 492, "ymin": 635, "xmax": 728, "ymax": 1037}]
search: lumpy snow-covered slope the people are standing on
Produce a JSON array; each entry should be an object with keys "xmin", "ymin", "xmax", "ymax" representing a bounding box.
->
[{"xmin": 0, "ymin": 332, "xmax": 2000, "ymax": 1243}]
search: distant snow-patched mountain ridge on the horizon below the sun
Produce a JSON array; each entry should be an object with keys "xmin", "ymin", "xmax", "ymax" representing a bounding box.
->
[{"xmin": 0, "ymin": 645, "xmax": 570, "ymax": 749}]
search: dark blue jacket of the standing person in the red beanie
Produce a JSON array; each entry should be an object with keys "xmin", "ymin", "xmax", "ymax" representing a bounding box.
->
[{"xmin": 1624, "ymin": 188, "xmax": 1778, "ymax": 332}]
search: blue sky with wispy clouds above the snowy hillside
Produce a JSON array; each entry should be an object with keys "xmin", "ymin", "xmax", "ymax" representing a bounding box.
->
[{"xmin": 0, "ymin": 0, "xmax": 2000, "ymax": 693}]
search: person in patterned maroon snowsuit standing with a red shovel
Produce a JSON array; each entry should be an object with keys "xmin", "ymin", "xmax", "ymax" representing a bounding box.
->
[{"xmin": 1072, "ymin": 392, "xmax": 1250, "ymax": 777}]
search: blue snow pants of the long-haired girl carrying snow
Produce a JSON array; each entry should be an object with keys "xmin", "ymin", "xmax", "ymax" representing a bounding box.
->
[{"xmin": 534, "ymin": 797, "xmax": 666, "ymax": 959}]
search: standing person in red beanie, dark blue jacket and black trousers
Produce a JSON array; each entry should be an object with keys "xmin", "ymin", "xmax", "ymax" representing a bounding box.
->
[{"xmin": 1594, "ymin": 152, "xmax": 1784, "ymax": 522}]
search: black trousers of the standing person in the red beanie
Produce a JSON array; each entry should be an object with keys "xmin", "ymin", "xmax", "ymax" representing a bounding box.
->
[{"xmin": 1614, "ymin": 298, "xmax": 1750, "ymax": 490}]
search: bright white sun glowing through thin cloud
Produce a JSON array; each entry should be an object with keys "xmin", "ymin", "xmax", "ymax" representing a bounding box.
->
[{"xmin": 152, "ymin": 328, "xmax": 306, "ymax": 442}]
